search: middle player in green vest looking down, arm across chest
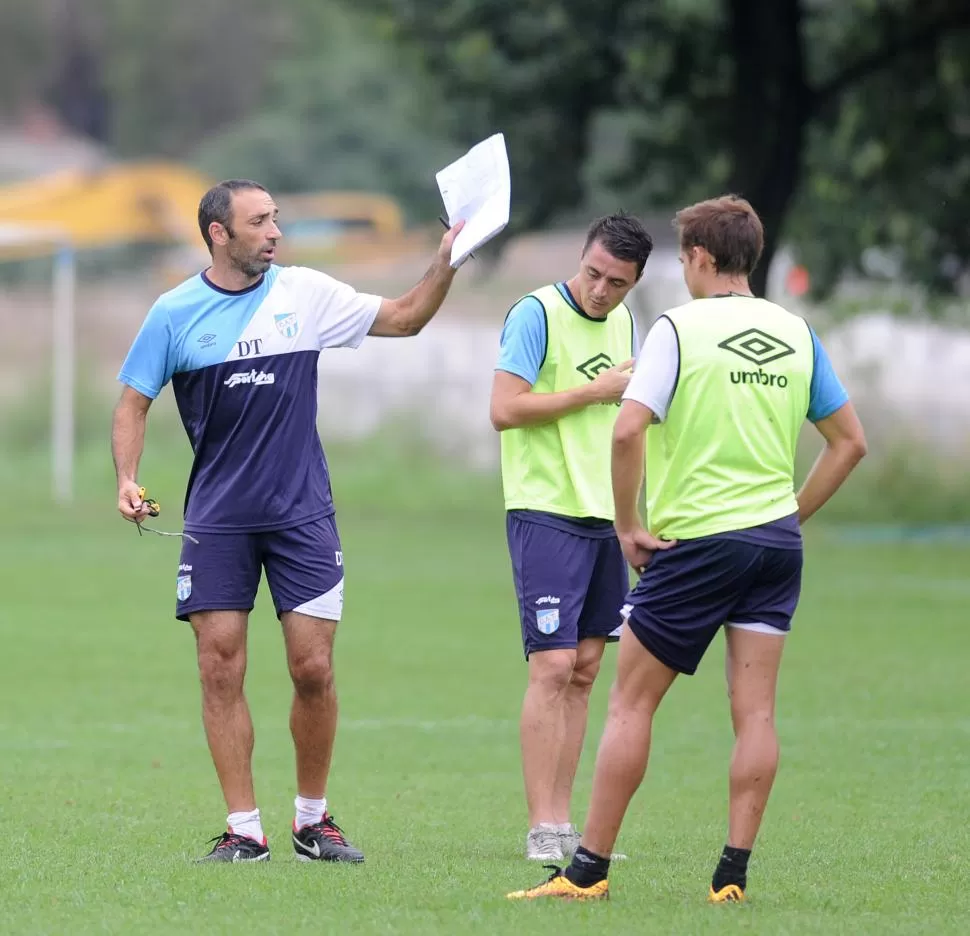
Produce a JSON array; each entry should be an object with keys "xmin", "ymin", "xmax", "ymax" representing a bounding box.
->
[{"xmin": 491, "ymin": 215, "xmax": 653, "ymax": 861}]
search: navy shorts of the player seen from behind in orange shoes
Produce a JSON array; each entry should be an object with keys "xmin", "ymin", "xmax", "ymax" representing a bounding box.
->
[{"xmin": 623, "ymin": 536, "xmax": 802, "ymax": 675}]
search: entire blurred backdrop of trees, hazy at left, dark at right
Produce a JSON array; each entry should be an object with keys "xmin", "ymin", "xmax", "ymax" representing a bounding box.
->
[{"xmin": 0, "ymin": 0, "xmax": 970, "ymax": 294}]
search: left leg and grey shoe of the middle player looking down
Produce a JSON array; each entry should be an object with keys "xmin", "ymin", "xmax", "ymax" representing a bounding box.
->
[{"xmin": 519, "ymin": 649, "xmax": 576, "ymax": 861}]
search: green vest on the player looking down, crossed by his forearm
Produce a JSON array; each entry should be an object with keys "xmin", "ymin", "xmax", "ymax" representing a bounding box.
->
[{"xmin": 501, "ymin": 286, "xmax": 635, "ymax": 520}]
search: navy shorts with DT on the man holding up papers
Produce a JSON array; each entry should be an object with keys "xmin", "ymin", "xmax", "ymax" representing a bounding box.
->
[{"xmin": 175, "ymin": 514, "xmax": 344, "ymax": 621}]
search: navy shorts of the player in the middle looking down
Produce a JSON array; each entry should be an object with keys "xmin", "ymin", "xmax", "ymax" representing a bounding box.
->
[{"xmin": 506, "ymin": 512, "xmax": 630, "ymax": 659}]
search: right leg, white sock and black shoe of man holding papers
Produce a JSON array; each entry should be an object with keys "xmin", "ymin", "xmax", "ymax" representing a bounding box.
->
[{"xmin": 281, "ymin": 611, "xmax": 364, "ymax": 864}]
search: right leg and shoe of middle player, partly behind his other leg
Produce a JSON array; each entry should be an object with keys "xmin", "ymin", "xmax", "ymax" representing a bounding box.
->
[{"xmin": 552, "ymin": 637, "xmax": 606, "ymax": 857}]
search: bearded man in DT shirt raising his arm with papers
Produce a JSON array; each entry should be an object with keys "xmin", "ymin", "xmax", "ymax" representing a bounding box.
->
[{"xmin": 112, "ymin": 180, "xmax": 461, "ymax": 863}]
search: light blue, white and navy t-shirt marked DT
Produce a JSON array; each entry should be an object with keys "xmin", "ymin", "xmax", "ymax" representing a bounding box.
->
[{"xmin": 118, "ymin": 266, "xmax": 382, "ymax": 533}]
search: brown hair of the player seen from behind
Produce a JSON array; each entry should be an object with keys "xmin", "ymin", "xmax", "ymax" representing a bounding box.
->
[{"xmin": 674, "ymin": 195, "xmax": 765, "ymax": 276}]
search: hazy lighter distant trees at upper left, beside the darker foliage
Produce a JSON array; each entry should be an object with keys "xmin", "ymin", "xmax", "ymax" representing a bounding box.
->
[{"xmin": 0, "ymin": 0, "xmax": 461, "ymax": 220}]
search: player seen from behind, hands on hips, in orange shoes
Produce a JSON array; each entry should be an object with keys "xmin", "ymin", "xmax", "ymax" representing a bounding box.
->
[{"xmin": 508, "ymin": 196, "xmax": 866, "ymax": 902}]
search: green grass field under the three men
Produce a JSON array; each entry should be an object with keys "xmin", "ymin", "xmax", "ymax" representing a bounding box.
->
[{"xmin": 0, "ymin": 442, "xmax": 970, "ymax": 936}]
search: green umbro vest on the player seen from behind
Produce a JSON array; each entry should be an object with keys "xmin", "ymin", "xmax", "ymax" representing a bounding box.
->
[{"xmin": 646, "ymin": 296, "xmax": 815, "ymax": 539}]
